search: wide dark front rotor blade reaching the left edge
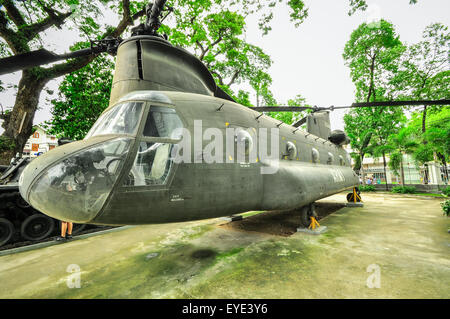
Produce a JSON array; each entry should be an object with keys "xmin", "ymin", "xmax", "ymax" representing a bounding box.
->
[{"xmin": 0, "ymin": 48, "xmax": 92, "ymax": 75}]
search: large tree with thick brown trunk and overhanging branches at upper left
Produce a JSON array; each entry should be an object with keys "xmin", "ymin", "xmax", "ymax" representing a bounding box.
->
[{"xmin": 0, "ymin": 0, "xmax": 148, "ymax": 163}]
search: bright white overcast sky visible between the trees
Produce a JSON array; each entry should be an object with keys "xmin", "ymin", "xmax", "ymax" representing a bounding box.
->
[{"xmin": 0, "ymin": 0, "xmax": 450, "ymax": 133}]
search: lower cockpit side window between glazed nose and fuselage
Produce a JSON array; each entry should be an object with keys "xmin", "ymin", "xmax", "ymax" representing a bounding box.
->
[{"xmin": 125, "ymin": 142, "xmax": 173, "ymax": 186}]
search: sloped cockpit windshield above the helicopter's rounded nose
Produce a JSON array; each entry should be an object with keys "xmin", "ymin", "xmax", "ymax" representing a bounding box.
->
[{"xmin": 85, "ymin": 102, "xmax": 143, "ymax": 139}]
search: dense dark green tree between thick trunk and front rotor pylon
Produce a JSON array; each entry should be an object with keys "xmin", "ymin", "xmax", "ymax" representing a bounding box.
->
[{"xmin": 43, "ymin": 51, "xmax": 114, "ymax": 140}]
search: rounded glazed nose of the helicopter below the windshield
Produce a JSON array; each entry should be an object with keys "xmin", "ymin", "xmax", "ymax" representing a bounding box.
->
[{"xmin": 19, "ymin": 138, "xmax": 131, "ymax": 223}]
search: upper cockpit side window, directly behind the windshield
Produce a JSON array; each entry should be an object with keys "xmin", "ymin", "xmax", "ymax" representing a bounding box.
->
[{"xmin": 143, "ymin": 106, "xmax": 183, "ymax": 139}]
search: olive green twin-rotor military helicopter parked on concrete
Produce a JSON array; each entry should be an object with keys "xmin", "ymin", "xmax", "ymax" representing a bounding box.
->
[{"xmin": 0, "ymin": 0, "xmax": 446, "ymax": 226}]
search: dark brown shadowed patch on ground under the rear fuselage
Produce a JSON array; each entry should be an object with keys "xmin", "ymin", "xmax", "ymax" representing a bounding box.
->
[{"xmin": 219, "ymin": 202, "xmax": 345, "ymax": 237}]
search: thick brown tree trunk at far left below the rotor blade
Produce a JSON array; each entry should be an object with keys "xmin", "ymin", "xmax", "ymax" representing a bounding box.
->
[{"xmin": 0, "ymin": 69, "xmax": 49, "ymax": 165}]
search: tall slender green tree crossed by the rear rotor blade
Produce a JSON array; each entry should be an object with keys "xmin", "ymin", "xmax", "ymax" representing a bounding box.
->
[{"xmin": 343, "ymin": 20, "xmax": 405, "ymax": 171}]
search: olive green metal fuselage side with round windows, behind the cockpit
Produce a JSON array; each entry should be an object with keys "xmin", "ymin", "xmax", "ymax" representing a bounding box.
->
[{"xmin": 92, "ymin": 92, "xmax": 358, "ymax": 224}]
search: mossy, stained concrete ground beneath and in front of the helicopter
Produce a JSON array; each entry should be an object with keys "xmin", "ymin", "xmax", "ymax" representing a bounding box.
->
[{"xmin": 0, "ymin": 193, "xmax": 450, "ymax": 298}]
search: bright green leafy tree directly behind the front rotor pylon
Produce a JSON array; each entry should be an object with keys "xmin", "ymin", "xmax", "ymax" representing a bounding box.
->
[{"xmin": 161, "ymin": 4, "xmax": 272, "ymax": 102}]
